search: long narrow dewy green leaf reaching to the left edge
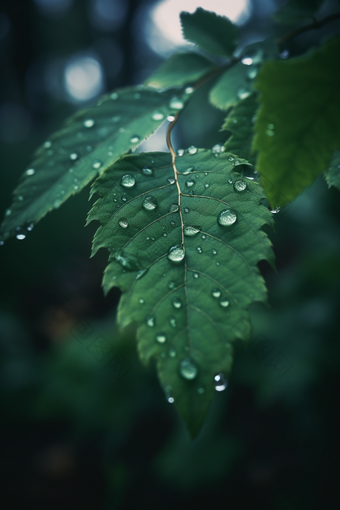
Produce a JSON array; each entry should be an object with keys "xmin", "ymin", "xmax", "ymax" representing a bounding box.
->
[{"xmin": 0, "ymin": 87, "xmax": 189, "ymax": 239}]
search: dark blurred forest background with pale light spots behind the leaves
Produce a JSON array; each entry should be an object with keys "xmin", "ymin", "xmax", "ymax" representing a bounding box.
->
[{"xmin": 0, "ymin": 0, "xmax": 340, "ymax": 510}]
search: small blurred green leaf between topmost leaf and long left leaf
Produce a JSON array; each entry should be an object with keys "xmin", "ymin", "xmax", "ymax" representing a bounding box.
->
[{"xmin": 145, "ymin": 53, "xmax": 215, "ymax": 89}]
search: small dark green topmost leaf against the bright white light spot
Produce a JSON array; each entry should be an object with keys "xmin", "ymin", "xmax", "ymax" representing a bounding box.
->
[{"xmin": 181, "ymin": 7, "xmax": 238, "ymax": 57}]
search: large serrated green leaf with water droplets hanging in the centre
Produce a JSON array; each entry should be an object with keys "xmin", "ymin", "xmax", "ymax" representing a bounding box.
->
[{"xmin": 88, "ymin": 148, "xmax": 273, "ymax": 436}]
